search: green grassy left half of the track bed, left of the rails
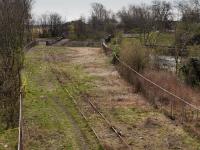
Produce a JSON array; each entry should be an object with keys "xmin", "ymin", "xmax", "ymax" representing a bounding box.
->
[{"xmin": 24, "ymin": 46, "xmax": 99, "ymax": 150}]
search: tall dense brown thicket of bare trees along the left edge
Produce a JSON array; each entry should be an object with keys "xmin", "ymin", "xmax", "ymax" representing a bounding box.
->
[{"xmin": 0, "ymin": 0, "xmax": 31, "ymax": 128}]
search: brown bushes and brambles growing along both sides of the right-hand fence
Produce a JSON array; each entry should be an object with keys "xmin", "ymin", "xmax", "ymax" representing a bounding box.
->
[{"xmin": 112, "ymin": 40, "xmax": 200, "ymax": 137}]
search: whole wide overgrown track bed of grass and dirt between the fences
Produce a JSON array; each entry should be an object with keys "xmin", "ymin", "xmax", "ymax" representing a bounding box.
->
[{"xmin": 24, "ymin": 46, "xmax": 200, "ymax": 150}]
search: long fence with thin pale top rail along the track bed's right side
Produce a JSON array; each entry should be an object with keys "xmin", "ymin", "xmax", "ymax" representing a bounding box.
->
[{"xmin": 102, "ymin": 42, "xmax": 200, "ymax": 123}]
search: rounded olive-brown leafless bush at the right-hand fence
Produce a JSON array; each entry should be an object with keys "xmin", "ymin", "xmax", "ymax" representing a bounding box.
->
[{"xmin": 117, "ymin": 39, "xmax": 149, "ymax": 92}]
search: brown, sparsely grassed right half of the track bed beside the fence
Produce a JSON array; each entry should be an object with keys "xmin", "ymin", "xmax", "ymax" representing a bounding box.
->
[{"xmin": 64, "ymin": 48, "xmax": 200, "ymax": 150}]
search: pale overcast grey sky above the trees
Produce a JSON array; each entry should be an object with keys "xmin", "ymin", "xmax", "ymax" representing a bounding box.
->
[{"xmin": 33, "ymin": 0, "xmax": 151, "ymax": 21}]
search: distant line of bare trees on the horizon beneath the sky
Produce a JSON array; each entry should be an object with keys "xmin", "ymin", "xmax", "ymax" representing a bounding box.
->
[{"xmin": 30, "ymin": 0, "xmax": 200, "ymax": 40}]
